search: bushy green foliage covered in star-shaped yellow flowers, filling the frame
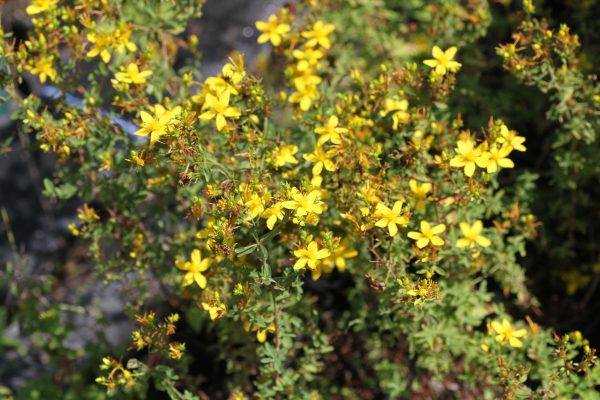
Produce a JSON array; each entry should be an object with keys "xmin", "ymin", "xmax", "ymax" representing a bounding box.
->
[{"xmin": 0, "ymin": 0, "xmax": 600, "ymax": 399}]
